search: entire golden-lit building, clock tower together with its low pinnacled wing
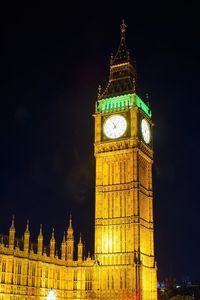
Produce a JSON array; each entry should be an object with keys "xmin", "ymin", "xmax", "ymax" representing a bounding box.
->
[{"xmin": 0, "ymin": 21, "xmax": 157, "ymax": 300}]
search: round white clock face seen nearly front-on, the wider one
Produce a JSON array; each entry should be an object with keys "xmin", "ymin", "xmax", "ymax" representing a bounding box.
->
[{"xmin": 103, "ymin": 115, "xmax": 127, "ymax": 139}]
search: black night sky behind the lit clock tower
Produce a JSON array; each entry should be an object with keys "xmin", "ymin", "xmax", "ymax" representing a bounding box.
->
[{"xmin": 0, "ymin": 1, "xmax": 200, "ymax": 279}]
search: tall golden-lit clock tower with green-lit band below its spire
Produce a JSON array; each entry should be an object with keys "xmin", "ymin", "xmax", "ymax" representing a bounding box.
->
[{"xmin": 94, "ymin": 22, "xmax": 157, "ymax": 300}]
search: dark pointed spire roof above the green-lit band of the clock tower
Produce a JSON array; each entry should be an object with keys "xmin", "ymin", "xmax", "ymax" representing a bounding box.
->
[{"xmin": 98, "ymin": 20, "xmax": 137, "ymax": 100}]
